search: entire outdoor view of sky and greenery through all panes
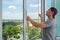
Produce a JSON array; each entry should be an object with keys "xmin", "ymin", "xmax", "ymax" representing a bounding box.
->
[{"xmin": 2, "ymin": 0, "xmax": 51, "ymax": 40}]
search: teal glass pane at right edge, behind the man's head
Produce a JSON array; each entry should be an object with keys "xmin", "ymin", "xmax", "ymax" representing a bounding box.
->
[{"xmin": 55, "ymin": 0, "xmax": 60, "ymax": 37}]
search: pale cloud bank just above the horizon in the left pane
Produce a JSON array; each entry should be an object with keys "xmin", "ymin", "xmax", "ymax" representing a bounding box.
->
[{"xmin": 2, "ymin": 12, "xmax": 23, "ymax": 19}]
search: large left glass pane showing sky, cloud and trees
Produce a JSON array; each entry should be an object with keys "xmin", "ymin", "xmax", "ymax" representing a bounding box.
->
[{"xmin": 2, "ymin": 0, "xmax": 23, "ymax": 40}]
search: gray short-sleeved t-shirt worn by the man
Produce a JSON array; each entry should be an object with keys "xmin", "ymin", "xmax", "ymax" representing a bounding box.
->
[{"xmin": 42, "ymin": 18, "xmax": 56, "ymax": 40}]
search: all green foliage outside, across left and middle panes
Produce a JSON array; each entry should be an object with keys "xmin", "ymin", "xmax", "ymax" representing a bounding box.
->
[{"xmin": 3, "ymin": 21, "xmax": 42, "ymax": 40}]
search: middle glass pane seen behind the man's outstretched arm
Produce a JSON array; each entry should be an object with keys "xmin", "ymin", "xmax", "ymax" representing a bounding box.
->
[{"xmin": 26, "ymin": 0, "xmax": 42, "ymax": 40}]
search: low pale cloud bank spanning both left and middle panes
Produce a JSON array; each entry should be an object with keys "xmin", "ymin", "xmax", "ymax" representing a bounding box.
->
[{"xmin": 2, "ymin": 12, "xmax": 38, "ymax": 19}]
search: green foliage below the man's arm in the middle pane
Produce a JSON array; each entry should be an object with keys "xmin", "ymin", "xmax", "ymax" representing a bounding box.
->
[{"xmin": 27, "ymin": 26, "xmax": 42, "ymax": 40}]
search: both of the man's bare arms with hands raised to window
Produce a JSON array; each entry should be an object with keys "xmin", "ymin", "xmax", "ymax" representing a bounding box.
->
[{"xmin": 27, "ymin": 15, "xmax": 46, "ymax": 28}]
